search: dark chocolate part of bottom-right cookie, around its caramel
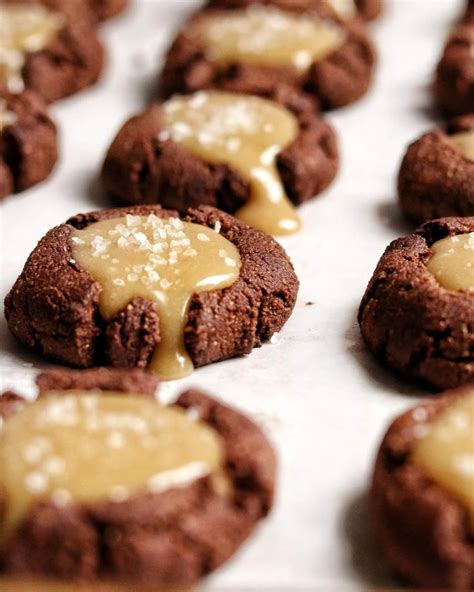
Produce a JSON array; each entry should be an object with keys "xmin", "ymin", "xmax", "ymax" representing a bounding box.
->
[{"xmin": 371, "ymin": 386, "xmax": 474, "ymax": 590}]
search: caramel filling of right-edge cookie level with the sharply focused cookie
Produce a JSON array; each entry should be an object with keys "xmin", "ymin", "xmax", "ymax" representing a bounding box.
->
[{"xmin": 428, "ymin": 232, "xmax": 474, "ymax": 292}]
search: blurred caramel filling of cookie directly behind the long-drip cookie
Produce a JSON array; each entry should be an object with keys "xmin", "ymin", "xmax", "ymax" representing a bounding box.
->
[{"xmin": 200, "ymin": 5, "xmax": 346, "ymax": 72}]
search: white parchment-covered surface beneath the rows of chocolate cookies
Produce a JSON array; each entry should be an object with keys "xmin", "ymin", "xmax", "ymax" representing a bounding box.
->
[{"xmin": 0, "ymin": 0, "xmax": 462, "ymax": 590}]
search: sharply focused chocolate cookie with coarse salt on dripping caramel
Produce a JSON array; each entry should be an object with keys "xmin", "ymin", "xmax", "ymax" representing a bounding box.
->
[{"xmin": 5, "ymin": 206, "xmax": 298, "ymax": 377}]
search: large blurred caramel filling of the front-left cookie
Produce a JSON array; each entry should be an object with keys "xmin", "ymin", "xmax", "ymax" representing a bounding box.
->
[{"xmin": 0, "ymin": 393, "xmax": 224, "ymax": 541}]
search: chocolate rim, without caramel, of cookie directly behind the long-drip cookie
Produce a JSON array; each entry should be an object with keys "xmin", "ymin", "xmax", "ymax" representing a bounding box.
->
[{"xmin": 159, "ymin": 0, "xmax": 375, "ymax": 109}]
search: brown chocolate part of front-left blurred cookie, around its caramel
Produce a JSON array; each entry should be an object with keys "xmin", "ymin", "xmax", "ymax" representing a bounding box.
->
[{"xmin": 0, "ymin": 370, "xmax": 276, "ymax": 588}]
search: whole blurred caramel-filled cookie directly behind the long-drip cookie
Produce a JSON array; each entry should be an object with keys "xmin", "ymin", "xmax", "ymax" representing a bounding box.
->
[{"xmin": 159, "ymin": 0, "xmax": 375, "ymax": 109}]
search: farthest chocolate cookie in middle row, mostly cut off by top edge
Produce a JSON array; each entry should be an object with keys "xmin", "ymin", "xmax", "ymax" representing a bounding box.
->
[{"xmin": 208, "ymin": 0, "xmax": 382, "ymax": 21}]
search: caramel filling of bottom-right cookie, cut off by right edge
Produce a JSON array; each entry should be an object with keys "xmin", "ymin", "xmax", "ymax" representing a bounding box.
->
[{"xmin": 413, "ymin": 390, "xmax": 474, "ymax": 532}]
